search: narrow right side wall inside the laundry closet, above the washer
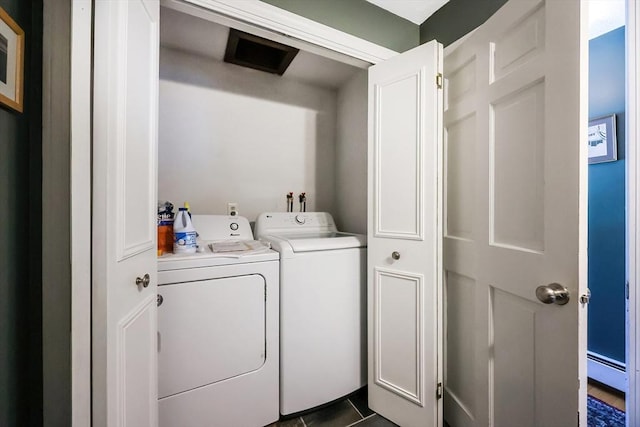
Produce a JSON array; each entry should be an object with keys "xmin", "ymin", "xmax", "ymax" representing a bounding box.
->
[{"xmin": 334, "ymin": 70, "xmax": 367, "ymax": 234}]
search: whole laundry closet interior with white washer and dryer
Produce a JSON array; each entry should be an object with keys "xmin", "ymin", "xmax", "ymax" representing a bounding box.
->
[{"xmin": 158, "ymin": 7, "xmax": 369, "ymax": 427}]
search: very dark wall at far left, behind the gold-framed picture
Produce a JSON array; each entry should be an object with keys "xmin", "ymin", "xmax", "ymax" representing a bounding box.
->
[{"xmin": 0, "ymin": 0, "xmax": 42, "ymax": 427}]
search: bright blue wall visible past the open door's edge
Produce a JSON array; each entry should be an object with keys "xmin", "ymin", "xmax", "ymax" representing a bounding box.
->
[{"xmin": 588, "ymin": 27, "xmax": 625, "ymax": 362}]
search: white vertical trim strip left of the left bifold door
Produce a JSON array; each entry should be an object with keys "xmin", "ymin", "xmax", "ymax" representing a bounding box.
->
[{"xmin": 70, "ymin": 0, "xmax": 93, "ymax": 427}]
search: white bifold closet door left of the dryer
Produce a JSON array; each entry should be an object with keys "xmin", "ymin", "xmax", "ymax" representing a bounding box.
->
[{"xmin": 92, "ymin": 0, "xmax": 159, "ymax": 427}]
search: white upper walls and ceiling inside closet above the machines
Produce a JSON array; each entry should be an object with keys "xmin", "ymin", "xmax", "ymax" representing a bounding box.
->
[{"xmin": 158, "ymin": 7, "xmax": 368, "ymax": 233}]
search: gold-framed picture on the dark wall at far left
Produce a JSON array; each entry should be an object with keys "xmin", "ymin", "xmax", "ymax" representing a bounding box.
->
[{"xmin": 0, "ymin": 7, "xmax": 24, "ymax": 112}]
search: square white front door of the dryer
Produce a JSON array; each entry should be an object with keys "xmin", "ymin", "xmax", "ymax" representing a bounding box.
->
[{"xmin": 158, "ymin": 274, "xmax": 266, "ymax": 398}]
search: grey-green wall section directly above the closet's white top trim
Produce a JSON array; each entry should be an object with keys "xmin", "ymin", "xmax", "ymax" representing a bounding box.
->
[{"xmin": 262, "ymin": 0, "xmax": 420, "ymax": 52}]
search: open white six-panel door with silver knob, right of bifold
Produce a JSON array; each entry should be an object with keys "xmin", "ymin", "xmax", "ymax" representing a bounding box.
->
[{"xmin": 444, "ymin": 0, "xmax": 588, "ymax": 427}]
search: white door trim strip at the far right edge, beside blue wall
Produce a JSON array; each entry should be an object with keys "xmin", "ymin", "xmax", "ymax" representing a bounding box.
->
[{"xmin": 625, "ymin": 0, "xmax": 640, "ymax": 426}]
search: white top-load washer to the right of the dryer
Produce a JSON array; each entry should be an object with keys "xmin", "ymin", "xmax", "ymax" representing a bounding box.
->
[{"xmin": 255, "ymin": 212, "xmax": 367, "ymax": 415}]
